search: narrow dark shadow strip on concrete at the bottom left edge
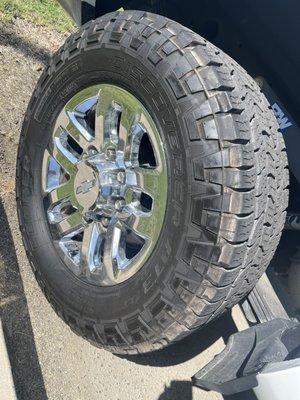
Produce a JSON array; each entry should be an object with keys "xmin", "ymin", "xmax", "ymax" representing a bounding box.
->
[{"xmin": 0, "ymin": 198, "xmax": 47, "ymax": 400}]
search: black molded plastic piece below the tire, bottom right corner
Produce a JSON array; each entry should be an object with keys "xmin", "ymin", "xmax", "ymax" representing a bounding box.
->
[{"xmin": 192, "ymin": 319, "xmax": 300, "ymax": 395}]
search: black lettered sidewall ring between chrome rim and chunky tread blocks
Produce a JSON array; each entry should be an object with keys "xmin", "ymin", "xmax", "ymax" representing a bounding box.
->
[{"xmin": 19, "ymin": 47, "xmax": 189, "ymax": 322}]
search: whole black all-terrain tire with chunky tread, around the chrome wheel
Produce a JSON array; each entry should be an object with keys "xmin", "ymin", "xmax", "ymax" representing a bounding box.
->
[{"xmin": 17, "ymin": 11, "xmax": 288, "ymax": 354}]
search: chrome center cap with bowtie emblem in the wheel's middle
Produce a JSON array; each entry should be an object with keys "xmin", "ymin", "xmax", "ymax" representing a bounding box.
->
[{"xmin": 74, "ymin": 163, "xmax": 99, "ymax": 211}]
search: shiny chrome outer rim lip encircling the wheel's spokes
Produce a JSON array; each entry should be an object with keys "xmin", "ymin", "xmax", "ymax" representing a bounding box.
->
[{"xmin": 42, "ymin": 83, "xmax": 168, "ymax": 286}]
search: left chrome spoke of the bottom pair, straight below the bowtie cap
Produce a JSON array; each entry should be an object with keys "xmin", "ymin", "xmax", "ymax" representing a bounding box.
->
[{"xmin": 81, "ymin": 222, "xmax": 103, "ymax": 275}]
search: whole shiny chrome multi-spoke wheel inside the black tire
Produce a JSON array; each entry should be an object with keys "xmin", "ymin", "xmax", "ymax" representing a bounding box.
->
[{"xmin": 42, "ymin": 84, "xmax": 167, "ymax": 286}]
